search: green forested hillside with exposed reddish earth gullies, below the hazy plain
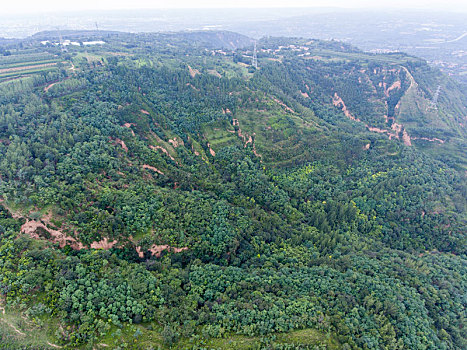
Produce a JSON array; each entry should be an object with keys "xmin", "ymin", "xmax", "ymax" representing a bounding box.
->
[{"xmin": 0, "ymin": 32, "xmax": 467, "ymax": 349}]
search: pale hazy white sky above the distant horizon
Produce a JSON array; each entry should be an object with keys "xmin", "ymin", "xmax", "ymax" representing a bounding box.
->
[{"xmin": 0, "ymin": 0, "xmax": 467, "ymax": 15}]
